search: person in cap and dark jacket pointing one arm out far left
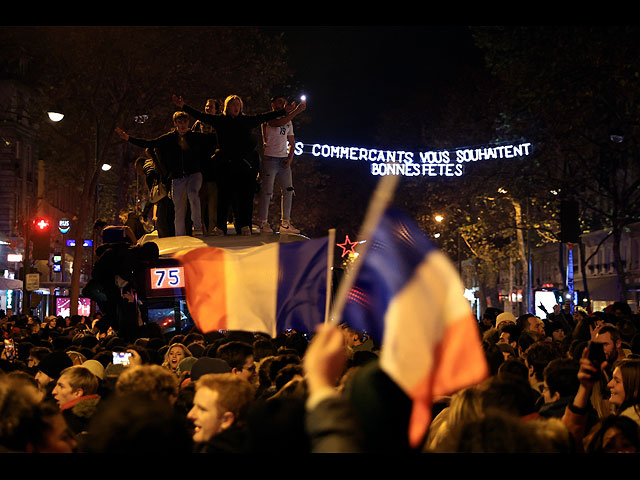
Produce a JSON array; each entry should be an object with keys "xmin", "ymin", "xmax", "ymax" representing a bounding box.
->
[{"xmin": 116, "ymin": 111, "xmax": 212, "ymax": 236}]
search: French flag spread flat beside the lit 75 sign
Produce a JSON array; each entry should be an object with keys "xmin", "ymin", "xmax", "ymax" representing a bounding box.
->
[{"xmin": 176, "ymin": 237, "xmax": 328, "ymax": 337}]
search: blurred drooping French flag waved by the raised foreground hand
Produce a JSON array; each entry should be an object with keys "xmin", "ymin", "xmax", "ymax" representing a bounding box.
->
[{"xmin": 342, "ymin": 209, "xmax": 488, "ymax": 446}]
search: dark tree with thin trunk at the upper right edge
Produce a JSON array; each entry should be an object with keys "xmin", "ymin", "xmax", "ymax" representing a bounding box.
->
[{"xmin": 475, "ymin": 26, "xmax": 640, "ymax": 300}]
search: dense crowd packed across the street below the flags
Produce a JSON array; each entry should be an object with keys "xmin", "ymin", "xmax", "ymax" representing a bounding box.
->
[{"xmin": 0, "ymin": 296, "xmax": 640, "ymax": 454}]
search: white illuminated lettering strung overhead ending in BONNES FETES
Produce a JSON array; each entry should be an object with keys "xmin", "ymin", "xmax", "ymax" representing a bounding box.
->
[{"xmin": 295, "ymin": 142, "xmax": 532, "ymax": 177}]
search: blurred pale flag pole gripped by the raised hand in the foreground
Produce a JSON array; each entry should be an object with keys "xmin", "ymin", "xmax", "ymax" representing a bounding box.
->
[{"xmin": 329, "ymin": 175, "xmax": 399, "ymax": 325}]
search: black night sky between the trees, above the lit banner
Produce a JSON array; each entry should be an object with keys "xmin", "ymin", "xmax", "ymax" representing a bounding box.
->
[{"xmin": 265, "ymin": 25, "xmax": 477, "ymax": 147}]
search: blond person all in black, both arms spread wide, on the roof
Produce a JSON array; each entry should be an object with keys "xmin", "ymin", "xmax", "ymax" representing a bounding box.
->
[{"xmin": 173, "ymin": 95, "xmax": 298, "ymax": 235}]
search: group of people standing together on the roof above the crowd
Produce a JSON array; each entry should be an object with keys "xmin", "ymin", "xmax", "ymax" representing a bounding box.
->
[{"xmin": 116, "ymin": 95, "xmax": 306, "ymax": 237}]
